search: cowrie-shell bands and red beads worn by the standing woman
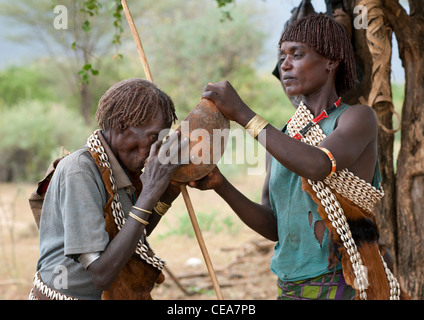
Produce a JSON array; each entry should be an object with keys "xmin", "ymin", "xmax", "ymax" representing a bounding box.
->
[{"xmin": 283, "ymin": 99, "xmax": 400, "ymax": 300}]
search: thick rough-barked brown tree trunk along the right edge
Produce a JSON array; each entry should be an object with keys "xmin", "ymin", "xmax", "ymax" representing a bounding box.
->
[{"xmin": 383, "ymin": 0, "xmax": 424, "ymax": 299}]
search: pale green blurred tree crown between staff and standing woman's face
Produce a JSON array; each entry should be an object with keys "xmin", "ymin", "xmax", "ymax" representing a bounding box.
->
[{"xmin": 147, "ymin": 1, "xmax": 264, "ymax": 118}]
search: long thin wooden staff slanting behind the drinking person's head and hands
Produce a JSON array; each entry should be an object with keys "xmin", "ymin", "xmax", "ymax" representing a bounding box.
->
[{"xmin": 121, "ymin": 0, "xmax": 224, "ymax": 300}]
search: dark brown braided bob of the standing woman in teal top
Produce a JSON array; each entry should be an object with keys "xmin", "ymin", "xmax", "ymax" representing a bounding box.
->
[{"xmin": 279, "ymin": 14, "xmax": 356, "ymax": 95}]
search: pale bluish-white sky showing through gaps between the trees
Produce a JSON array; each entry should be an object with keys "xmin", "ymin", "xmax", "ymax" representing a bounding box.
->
[{"xmin": 0, "ymin": 0, "xmax": 404, "ymax": 83}]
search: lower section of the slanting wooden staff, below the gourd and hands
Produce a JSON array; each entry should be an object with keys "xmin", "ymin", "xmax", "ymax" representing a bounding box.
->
[{"xmin": 180, "ymin": 184, "xmax": 224, "ymax": 300}]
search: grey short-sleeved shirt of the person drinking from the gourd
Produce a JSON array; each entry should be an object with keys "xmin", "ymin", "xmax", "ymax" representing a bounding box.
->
[{"xmin": 37, "ymin": 134, "xmax": 135, "ymax": 299}]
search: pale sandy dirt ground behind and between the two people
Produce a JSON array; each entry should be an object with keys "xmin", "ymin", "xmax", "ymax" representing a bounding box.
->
[{"xmin": 0, "ymin": 172, "xmax": 277, "ymax": 300}]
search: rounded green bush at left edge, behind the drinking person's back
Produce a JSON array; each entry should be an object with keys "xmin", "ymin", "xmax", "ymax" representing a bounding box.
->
[{"xmin": 0, "ymin": 101, "xmax": 90, "ymax": 182}]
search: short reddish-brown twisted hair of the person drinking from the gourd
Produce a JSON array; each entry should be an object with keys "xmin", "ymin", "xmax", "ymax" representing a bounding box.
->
[{"xmin": 96, "ymin": 79, "xmax": 177, "ymax": 131}]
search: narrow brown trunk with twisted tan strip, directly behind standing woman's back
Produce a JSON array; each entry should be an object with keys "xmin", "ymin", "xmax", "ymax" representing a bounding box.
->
[{"xmin": 355, "ymin": 0, "xmax": 397, "ymax": 269}]
